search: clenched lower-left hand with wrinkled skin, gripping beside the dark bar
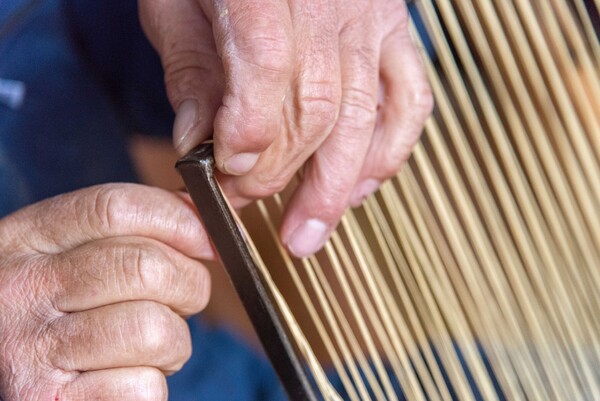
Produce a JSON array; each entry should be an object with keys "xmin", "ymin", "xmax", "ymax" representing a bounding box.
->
[{"xmin": 0, "ymin": 185, "xmax": 214, "ymax": 401}]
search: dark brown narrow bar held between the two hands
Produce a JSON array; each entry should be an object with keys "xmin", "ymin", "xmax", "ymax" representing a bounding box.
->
[{"xmin": 176, "ymin": 144, "xmax": 317, "ymax": 401}]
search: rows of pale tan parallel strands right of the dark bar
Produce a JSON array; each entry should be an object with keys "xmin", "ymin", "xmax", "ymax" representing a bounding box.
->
[{"xmin": 234, "ymin": 0, "xmax": 600, "ymax": 401}]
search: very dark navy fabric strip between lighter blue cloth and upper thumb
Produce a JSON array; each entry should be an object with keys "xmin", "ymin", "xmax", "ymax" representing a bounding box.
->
[{"xmin": 64, "ymin": 0, "xmax": 174, "ymax": 136}]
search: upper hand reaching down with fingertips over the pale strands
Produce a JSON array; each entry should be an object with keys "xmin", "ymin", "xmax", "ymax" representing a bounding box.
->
[{"xmin": 140, "ymin": 0, "xmax": 433, "ymax": 256}]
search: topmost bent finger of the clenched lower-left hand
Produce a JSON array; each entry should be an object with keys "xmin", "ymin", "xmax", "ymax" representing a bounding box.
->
[{"xmin": 0, "ymin": 184, "xmax": 215, "ymax": 259}]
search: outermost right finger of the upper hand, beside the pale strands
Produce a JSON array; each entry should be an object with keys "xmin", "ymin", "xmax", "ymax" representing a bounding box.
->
[{"xmin": 351, "ymin": 6, "xmax": 433, "ymax": 206}]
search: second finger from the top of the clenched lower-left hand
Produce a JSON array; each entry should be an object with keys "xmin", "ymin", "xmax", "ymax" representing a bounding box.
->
[{"xmin": 50, "ymin": 237, "xmax": 210, "ymax": 316}]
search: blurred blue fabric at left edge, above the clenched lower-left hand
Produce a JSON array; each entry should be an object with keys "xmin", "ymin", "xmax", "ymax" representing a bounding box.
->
[{"xmin": 0, "ymin": 0, "xmax": 135, "ymax": 215}]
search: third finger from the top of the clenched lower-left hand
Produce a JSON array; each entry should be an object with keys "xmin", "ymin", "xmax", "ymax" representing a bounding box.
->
[{"xmin": 48, "ymin": 301, "xmax": 192, "ymax": 373}]
